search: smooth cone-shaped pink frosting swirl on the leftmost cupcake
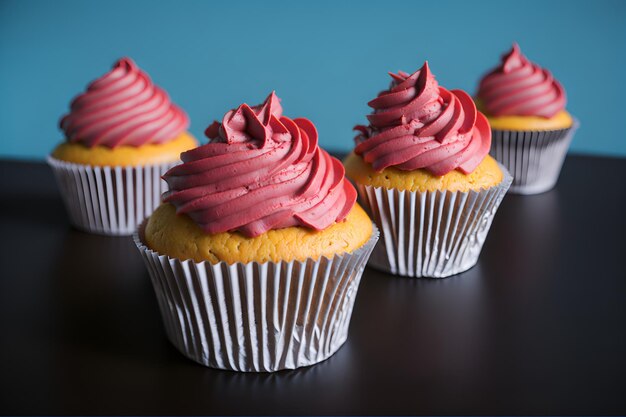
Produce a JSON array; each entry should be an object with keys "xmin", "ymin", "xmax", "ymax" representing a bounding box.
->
[{"xmin": 60, "ymin": 58, "xmax": 189, "ymax": 148}]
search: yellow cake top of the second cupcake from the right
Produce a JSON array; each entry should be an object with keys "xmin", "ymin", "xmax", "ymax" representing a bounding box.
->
[{"xmin": 344, "ymin": 152, "xmax": 503, "ymax": 192}]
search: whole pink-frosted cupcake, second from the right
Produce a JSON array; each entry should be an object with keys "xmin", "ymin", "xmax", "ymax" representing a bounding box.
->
[{"xmin": 345, "ymin": 63, "xmax": 511, "ymax": 278}]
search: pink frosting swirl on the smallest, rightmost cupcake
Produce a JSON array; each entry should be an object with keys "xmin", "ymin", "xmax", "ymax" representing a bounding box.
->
[{"xmin": 477, "ymin": 43, "xmax": 566, "ymax": 118}]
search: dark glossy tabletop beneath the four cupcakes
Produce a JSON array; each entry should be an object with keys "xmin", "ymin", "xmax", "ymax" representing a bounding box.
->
[{"xmin": 0, "ymin": 156, "xmax": 626, "ymax": 414}]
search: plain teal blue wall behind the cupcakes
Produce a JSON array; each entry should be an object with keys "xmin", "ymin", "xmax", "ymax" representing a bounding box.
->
[{"xmin": 0, "ymin": 0, "xmax": 626, "ymax": 159}]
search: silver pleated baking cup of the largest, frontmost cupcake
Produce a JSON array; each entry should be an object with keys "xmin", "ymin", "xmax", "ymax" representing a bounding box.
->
[{"xmin": 134, "ymin": 223, "xmax": 378, "ymax": 372}]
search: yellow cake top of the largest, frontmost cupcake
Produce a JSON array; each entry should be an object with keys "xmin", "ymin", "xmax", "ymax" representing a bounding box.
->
[{"xmin": 144, "ymin": 203, "xmax": 372, "ymax": 264}]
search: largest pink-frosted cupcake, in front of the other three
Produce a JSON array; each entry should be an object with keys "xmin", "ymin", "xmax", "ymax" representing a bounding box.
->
[{"xmin": 135, "ymin": 93, "xmax": 378, "ymax": 372}]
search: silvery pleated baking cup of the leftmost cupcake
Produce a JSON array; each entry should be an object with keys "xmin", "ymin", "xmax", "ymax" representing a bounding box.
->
[{"xmin": 47, "ymin": 156, "xmax": 176, "ymax": 236}]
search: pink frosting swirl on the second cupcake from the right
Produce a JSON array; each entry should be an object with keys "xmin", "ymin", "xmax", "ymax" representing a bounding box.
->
[{"xmin": 355, "ymin": 62, "xmax": 491, "ymax": 176}]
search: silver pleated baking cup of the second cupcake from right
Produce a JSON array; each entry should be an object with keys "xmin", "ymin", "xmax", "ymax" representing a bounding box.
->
[{"xmin": 357, "ymin": 165, "xmax": 512, "ymax": 278}]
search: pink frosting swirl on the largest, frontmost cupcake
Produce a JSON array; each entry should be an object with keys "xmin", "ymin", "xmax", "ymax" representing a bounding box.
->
[{"xmin": 164, "ymin": 93, "xmax": 356, "ymax": 237}]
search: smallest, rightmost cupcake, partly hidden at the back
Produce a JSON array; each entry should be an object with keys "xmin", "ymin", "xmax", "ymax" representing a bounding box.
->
[{"xmin": 476, "ymin": 44, "xmax": 578, "ymax": 194}]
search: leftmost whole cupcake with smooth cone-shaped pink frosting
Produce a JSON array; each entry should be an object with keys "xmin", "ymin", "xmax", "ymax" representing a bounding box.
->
[{"xmin": 48, "ymin": 58, "xmax": 197, "ymax": 235}]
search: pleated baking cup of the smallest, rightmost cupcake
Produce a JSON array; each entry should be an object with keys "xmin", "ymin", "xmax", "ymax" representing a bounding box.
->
[{"xmin": 489, "ymin": 120, "xmax": 579, "ymax": 194}]
